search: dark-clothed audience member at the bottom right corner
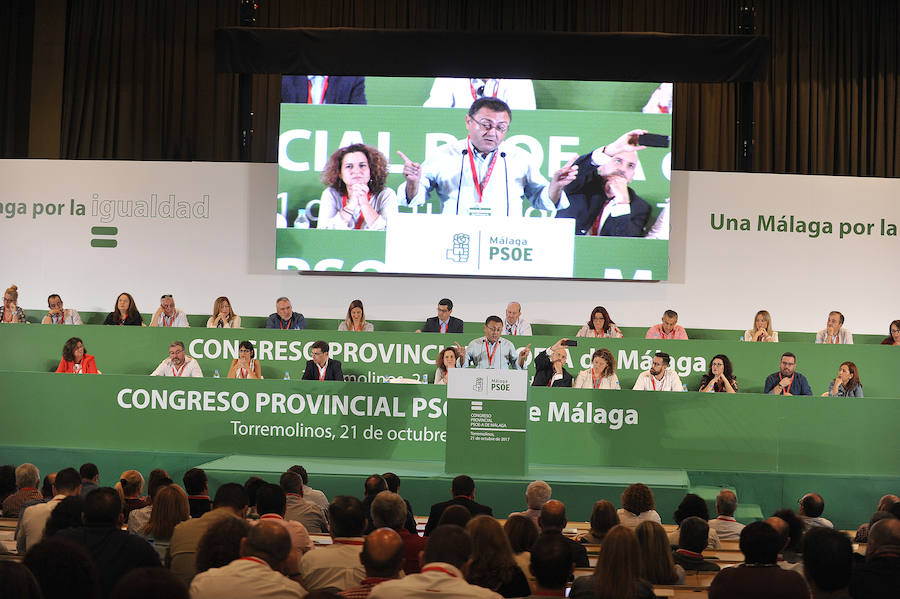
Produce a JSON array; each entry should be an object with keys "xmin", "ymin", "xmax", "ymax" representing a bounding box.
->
[{"xmin": 850, "ymin": 518, "xmax": 900, "ymax": 599}]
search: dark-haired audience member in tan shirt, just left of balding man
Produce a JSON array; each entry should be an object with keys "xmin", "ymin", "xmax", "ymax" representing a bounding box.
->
[{"xmin": 300, "ymin": 495, "xmax": 366, "ymax": 591}]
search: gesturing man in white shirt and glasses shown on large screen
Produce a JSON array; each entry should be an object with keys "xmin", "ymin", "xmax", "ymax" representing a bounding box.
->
[{"xmin": 397, "ymin": 98, "xmax": 578, "ymax": 217}]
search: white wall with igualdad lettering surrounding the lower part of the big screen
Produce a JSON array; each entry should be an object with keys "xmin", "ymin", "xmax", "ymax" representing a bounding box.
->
[{"xmin": 0, "ymin": 160, "xmax": 900, "ymax": 334}]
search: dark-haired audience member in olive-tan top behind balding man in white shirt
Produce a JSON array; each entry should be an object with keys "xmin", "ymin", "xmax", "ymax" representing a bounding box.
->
[{"xmin": 169, "ymin": 483, "xmax": 247, "ymax": 582}]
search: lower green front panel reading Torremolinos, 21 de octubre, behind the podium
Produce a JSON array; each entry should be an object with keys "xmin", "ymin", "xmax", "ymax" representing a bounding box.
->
[{"xmin": 0, "ymin": 371, "xmax": 900, "ymax": 476}]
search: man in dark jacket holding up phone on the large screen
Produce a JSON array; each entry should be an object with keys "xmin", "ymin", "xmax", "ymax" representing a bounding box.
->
[{"xmin": 556, "ymin": 129, "xmax": 650, "ymax": 237}]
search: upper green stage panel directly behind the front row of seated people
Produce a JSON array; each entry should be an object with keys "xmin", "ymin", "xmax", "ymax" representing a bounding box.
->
[{"xmin": 0, "ymin": 325, "xmax": 900, "ymax": 396}]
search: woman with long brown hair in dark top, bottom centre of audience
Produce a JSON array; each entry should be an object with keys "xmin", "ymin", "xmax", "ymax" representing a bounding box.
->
[{"xmin": 466, "ymin": 515, "xmax": 531, "ymax": 597}]
